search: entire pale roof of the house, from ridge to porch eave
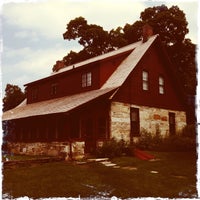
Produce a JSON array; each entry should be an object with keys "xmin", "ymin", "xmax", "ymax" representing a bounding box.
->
[{"xmin": 2, "ymin": 35, "xmax": 158, "ymax": 120}]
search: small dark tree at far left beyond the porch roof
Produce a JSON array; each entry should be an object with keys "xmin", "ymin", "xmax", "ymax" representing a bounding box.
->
[{"xmin": 3, "ymin": 84, "xmax": 25, "ymax": 112}]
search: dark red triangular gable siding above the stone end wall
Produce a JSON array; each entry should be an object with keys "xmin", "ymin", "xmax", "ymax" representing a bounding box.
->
[{"xmin": 114, "ymin": 45, "xmax": 184, "ymax": 110}]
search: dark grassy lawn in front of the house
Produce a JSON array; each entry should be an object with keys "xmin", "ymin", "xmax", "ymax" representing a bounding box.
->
[{"xmin": 3, "ymin": 152, "xmax": 197, "ymax": 199}]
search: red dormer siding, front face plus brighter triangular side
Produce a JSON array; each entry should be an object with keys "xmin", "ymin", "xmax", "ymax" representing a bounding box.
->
[{"xmin": 27, "ymin": 51, "xmax": 130, "ymax": 103}]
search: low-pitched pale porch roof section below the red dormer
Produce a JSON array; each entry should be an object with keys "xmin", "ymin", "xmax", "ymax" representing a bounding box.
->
[{"xmin": 2, "ymin": 87, "xmax": 117, "ymax": 121}]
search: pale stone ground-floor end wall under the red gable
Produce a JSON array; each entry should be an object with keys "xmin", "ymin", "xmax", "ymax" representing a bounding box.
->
[{"xmin": 110, "ymin": 102, "xmax": 186, "ymax": 142}]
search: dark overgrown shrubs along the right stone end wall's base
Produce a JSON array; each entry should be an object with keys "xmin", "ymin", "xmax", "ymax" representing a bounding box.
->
[{"xmin": 136, "ymin": 126, "xmax": 196, "ymax": 152}]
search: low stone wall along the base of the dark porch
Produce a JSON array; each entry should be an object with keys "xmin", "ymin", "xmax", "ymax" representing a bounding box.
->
[{"xmin": 8, "ymin": 142, "xmax": 85, "ymax": 159}]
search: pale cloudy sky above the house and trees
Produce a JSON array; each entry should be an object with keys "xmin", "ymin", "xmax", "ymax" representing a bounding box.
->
[{"xmin": 0, "ymin": 0, "xmax": 198, "ymax": 96}]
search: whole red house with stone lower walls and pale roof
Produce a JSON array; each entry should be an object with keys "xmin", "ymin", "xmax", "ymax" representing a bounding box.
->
[{"xmin": 3, "ymin": 35, "xmax": 186, "ymax": 159}]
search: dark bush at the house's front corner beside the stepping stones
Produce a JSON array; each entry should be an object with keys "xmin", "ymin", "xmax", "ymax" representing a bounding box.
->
[{"xmin": 96, "ymin": 138, "xmax": 127, "ymax": 158}]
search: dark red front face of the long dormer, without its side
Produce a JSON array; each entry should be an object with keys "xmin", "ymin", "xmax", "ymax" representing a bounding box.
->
[{"xmin": 27, "ymin": 63, "xmax": 99, "ymax": 103}]
